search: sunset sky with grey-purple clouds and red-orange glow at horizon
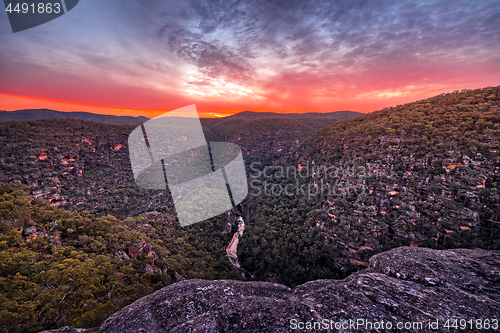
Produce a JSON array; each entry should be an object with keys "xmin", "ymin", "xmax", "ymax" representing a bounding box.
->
[{"xmin": 0, "ymin": 0, "xmax": 500, "ymax": 118}]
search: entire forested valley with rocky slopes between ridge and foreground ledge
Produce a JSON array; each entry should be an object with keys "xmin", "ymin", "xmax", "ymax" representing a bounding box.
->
[{"xmin": 0, "ymin": 87, "xmax": 500, "ymax": 332}]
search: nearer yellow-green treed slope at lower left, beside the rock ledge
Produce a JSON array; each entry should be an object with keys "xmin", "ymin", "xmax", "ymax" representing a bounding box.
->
[{"xmin": 0, "ymin": 186, "xmax": 241, "ymax": 332}]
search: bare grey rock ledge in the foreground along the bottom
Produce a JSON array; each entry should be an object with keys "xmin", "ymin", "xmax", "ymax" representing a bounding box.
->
[{"xmin": 42, "ymin": 247, "xmax": 500, "ymax": 333}]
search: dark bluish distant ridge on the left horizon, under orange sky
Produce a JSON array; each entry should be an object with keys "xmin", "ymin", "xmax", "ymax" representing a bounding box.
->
[{"xmin": 0, "ymin": 109, "xmax": 149, "ymax": 125}]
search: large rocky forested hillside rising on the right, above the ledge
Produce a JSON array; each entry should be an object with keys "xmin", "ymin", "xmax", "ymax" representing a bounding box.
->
[{"xmin": 239, "ymin": 87, "xmax": 500, "ymax": 285}]
